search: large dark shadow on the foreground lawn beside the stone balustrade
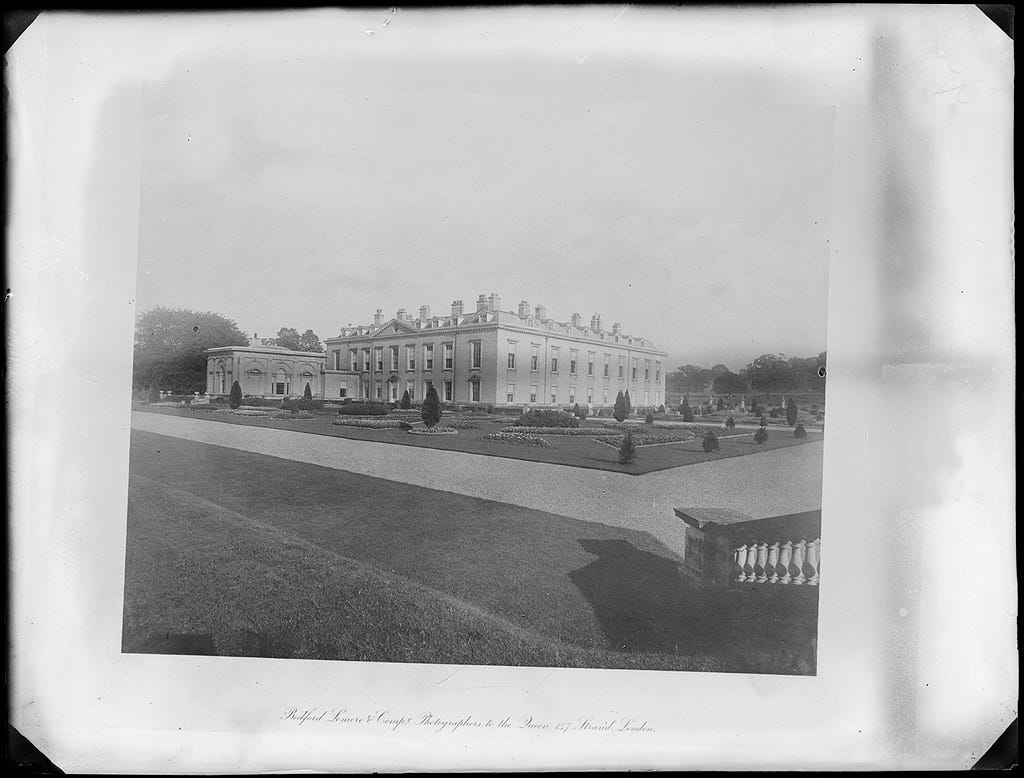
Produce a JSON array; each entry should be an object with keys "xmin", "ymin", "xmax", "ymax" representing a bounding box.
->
[{"xmin": 568, "ymin": 538, "xmax": 817, "ymax": 675}]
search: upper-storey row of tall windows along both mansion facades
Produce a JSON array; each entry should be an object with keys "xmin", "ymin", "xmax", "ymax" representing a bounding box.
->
[{"xmin": 334, "ymin": 341, "xmax": 662, "ymax": 382}]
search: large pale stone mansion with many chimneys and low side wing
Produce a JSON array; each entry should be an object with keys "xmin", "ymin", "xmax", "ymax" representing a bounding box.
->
[{"xmin": 207, "ymin": 294, "xmax": 667, "ymax": 406}]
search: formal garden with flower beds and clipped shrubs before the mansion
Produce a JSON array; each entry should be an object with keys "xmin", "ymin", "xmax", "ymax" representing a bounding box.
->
[{"xmin": 135, "ymin": 385, "xmax": 823, "ymax": 474}]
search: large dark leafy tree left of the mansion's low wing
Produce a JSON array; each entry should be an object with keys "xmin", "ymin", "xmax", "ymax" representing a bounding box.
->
[{"xmin": 132, "ymin": 306, "xmax": 249, "ymax": 394}]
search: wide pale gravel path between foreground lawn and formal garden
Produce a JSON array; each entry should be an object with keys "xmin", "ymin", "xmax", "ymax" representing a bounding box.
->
[{"xmin": 132, "ymin": 412, "xmax": 823, "ymax": 555}]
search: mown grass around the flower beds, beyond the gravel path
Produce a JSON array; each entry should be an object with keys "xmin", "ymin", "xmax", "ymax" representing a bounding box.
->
[{"xmin": 135, "ymin": 404, "xmax": 821, "ymax": 475}]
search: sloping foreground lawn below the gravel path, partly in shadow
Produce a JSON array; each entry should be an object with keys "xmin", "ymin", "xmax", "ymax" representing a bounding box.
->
[{"xmin": 123, "ymin": 430, "xmax": 817, "ymax": 674}]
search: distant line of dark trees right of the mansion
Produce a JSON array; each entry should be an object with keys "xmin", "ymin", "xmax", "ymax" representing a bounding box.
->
[{"xmin": 666, "ymin": 351, "xmax": 827, "ymax": 395}]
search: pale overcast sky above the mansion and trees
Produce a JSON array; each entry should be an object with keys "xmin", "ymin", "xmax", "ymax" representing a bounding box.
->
[{"xmin": 137, "ymin": 8, "xmax": 833, "ymax": 370}]
